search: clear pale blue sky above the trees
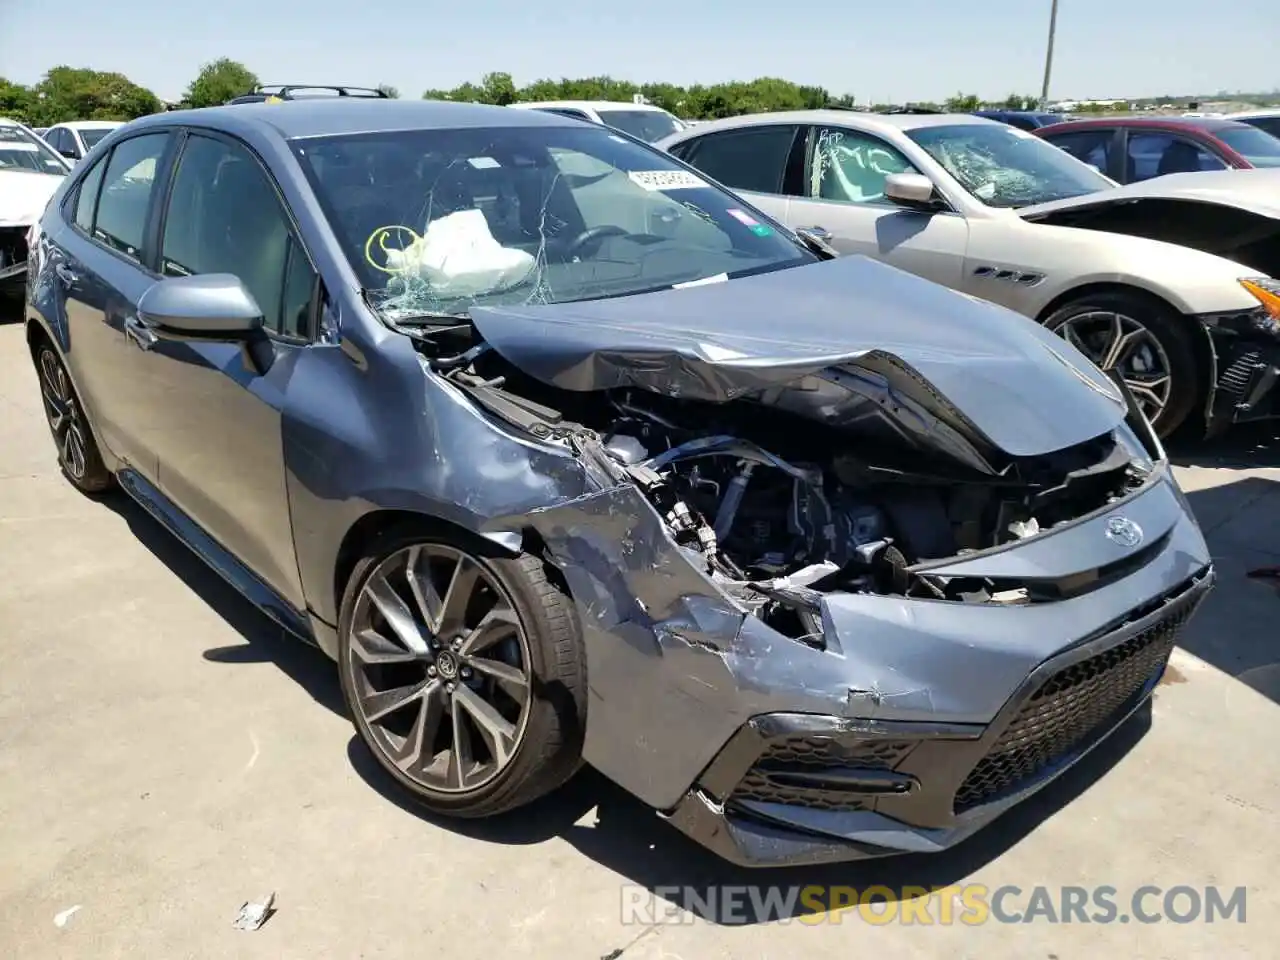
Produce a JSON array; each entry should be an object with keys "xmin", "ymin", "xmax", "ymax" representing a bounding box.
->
[{"xmin": 0, "ymin": 0, "xmax": 1280, "ymax": 101}]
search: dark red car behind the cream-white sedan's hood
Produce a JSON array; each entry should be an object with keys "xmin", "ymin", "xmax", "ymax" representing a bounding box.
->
[{"xmin": 1036, "ymin": 116, "xmax": 1280, "ymax": 183}]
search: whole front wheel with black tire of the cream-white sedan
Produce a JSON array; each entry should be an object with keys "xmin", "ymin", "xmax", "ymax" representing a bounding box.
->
[{"xmin": 1044, "ymin": 291, "xmax": 1204, "ymax": 438}]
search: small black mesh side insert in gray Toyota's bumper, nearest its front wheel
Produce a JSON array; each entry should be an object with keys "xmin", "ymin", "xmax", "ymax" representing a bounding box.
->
[{"xmin": 730, "ymin": 736, "xmax": 915, "ymax": 810}]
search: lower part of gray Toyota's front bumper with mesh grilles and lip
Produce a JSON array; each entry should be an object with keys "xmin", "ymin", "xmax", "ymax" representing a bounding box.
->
[{"xmin": 667, "ymin": 567, "xmax": 1213, "ymax": 867}]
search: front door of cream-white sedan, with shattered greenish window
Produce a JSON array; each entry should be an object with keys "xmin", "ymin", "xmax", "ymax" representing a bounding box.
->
[{"xmin": 787, "ymin": 127, "xmax": 969, "ymax": 288}]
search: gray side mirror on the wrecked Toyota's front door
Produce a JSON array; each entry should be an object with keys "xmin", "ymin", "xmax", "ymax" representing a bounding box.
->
[{"xmin": 138, "ymin": 274, "xmax": 262, "ymax": 342}]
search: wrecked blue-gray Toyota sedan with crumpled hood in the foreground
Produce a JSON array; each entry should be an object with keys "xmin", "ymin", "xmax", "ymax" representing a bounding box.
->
[{"xmin": 27, "ymin": 101, "xmax": 1213, "ymax": 865}]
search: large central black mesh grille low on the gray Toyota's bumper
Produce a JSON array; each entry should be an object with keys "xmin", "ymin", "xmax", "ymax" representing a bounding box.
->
[{"xmin": 955, "ymin": 603, "xmax": 1193, "ymax": 813}]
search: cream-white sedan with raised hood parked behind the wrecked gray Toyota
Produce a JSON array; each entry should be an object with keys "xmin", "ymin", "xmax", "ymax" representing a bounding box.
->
[{"xmin": 657, "ymin": 110, "xmax": 1280, "ymax": 435}]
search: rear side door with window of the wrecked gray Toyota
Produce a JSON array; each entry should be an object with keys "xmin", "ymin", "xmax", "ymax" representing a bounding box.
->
[{"xmin": 54, "ymin": 131, "xmax": 173, "ymax": 483}]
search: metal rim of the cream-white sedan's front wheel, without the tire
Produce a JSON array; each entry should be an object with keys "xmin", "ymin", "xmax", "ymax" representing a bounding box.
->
[{"xmin": 1050, "ymin": 310, "xmax": 1174, "ymax": 422}]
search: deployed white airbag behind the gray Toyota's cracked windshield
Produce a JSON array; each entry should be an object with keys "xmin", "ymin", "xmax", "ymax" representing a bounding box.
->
[{"xmin": 387, "ymin": 210, "xmax": 535, "ymax": 300}]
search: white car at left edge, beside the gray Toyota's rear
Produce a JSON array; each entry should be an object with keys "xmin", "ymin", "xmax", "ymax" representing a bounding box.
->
[{"xmin": 0, "ymin": 116, "xmax": 72, "ymax": 293}]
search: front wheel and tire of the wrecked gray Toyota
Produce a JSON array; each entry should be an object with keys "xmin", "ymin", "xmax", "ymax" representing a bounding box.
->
[{"xmin": 338, "ymin": 531, "xmax": 586, "ymax": 818}]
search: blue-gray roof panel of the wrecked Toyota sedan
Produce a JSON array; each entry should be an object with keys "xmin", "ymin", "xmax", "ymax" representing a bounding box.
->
[{"xmin": 132, "ymin": 97, "xmax": 579, "ymax": 140}]
